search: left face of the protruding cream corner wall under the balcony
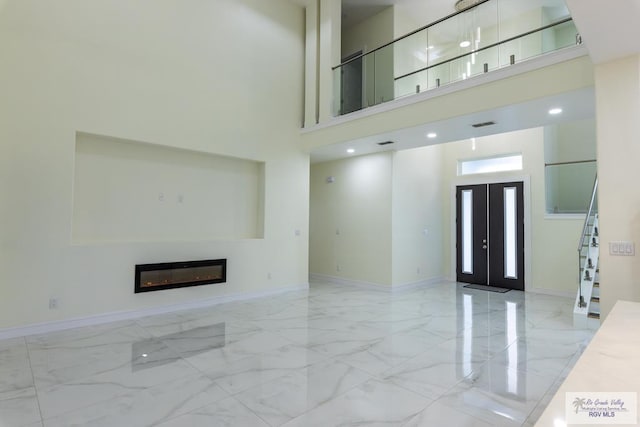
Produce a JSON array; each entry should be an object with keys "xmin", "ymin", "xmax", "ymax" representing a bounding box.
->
[{"xmin": 309, "ymin": 153, "xmax": 393, "ymax": 286}]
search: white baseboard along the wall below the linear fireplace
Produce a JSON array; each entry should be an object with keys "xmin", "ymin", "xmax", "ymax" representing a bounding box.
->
[{"xmin": 0, "ymin": 283, "xmax": 309, "ymax": 340}]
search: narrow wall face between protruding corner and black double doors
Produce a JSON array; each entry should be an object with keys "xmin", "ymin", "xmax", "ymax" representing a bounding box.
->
[{"xmin": 392, "ymin": 145, "xmax": 448, "ymax": 286}]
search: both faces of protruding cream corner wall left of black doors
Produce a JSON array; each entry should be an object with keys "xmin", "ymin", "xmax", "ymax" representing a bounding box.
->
[{"xmin": 309, "ymin": 146, "xmax": 442, "ymax": 286}]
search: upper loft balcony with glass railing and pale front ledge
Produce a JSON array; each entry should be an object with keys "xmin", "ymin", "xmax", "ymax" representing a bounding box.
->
[{"xmin": 302, "ymin": 0, "xmax": 593, "ymax": 159}]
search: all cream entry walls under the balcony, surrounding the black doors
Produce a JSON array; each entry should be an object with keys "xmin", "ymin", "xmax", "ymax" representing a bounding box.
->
[{"xmin": 310, "ymin": 128, "xmax": 584, "ymax": 295}]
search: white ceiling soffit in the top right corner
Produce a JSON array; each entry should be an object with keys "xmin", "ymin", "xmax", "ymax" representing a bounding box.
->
[{"xmin": 566, "ymin": 0, "xmax": 640, "ymax": 64}]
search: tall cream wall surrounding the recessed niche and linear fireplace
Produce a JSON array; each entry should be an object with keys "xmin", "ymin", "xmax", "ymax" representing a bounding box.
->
[{"xmin": 0, "ymin": 0, "xmax": 309, "ymax": 328}]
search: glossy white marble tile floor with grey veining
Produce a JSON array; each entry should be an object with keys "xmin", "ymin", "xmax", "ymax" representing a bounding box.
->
[{"xmin": 0, "ymin": 282, "xmax": 593, "ymax": 427}]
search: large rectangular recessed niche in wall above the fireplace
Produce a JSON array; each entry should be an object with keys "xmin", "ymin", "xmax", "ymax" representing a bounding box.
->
[{"xmin": 73, "ymin": 133, "xmax": 265, "ymax": 243}]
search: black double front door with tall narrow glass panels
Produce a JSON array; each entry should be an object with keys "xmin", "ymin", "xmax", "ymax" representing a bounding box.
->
[{"xmin": 456, "ymin": 182, "xmax": 524, "ymax": 290}]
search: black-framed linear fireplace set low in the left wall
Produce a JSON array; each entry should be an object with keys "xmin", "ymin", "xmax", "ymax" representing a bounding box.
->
[{"xmin": 135, "ymin": 259, "xmax": 227, "ymax": 293}]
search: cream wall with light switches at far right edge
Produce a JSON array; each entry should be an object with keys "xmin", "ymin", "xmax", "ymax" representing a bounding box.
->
[{"xmin": 595, "ymin": 55, "xmax": 640, "ymax": 319}]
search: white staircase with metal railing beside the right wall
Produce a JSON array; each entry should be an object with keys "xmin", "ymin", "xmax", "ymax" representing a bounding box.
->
[{"xmin": 573, "ymin": 177, "xmax": 600, "ymax": 328}]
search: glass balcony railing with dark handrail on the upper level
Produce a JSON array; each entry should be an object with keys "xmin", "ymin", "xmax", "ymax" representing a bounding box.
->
[{"xmin": 333, "ymin": 0, "xmax": 580, "ymax": 116}]
